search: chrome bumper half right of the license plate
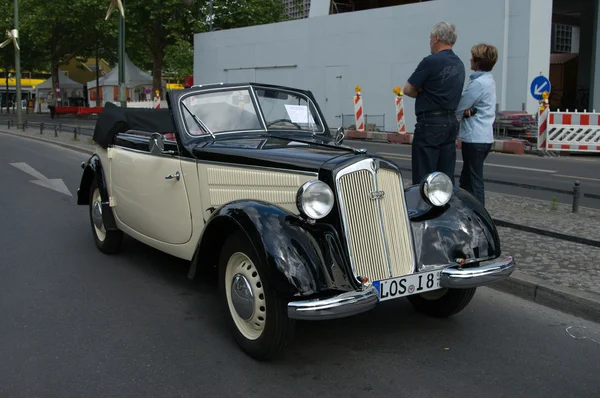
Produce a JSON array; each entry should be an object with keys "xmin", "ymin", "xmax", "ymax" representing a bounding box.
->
[{"xmin": 440, "ymin": 257, "xmax": 516, "ymax": 289}]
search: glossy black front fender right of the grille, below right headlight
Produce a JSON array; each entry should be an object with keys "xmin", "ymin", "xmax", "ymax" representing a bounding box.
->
[{"xmin": 405, "ymin": 185, "xmax": 502, "ymax": 270}]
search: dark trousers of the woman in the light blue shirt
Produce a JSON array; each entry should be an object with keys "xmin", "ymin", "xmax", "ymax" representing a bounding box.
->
[{"xmin": 459, "ymin": 142, "xmax": 492, "ymax": 206}]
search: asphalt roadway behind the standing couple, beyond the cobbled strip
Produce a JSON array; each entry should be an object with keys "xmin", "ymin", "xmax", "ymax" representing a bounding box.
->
[{"xmin": 346, "ymin": 141, "xmax": 600, "ymax": 208}]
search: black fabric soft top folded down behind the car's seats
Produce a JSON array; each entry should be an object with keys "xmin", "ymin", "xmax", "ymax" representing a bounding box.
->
[{"xmin": 93, "ymin": 102, "xmax": 175, "ymax": 148}]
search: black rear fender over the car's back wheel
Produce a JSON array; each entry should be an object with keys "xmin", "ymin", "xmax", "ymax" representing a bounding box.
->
[{"xmin": 77, "ymin": 154, "xmax": 117, "ymax": 230}]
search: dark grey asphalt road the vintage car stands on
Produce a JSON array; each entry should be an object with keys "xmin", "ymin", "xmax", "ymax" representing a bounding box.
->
[{"xmin": 0, "ymin": 135, "xmax": 600, "ymax": 397}]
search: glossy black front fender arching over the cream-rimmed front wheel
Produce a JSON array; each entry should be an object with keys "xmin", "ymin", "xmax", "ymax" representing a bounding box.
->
[{"xmin": 188, "ymin": 200, "xmax": 357, "ymax": 297}]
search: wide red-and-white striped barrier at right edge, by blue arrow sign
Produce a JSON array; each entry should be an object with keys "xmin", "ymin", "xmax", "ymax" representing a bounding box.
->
[{"xmin": 538, "ymin": 109, "xmax": 600, "ymax": 152}]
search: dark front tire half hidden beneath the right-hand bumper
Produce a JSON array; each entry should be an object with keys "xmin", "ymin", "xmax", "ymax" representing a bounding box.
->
[{"xmin": 407, "ymin": 288, "xmax": 477, "ymax": 318}]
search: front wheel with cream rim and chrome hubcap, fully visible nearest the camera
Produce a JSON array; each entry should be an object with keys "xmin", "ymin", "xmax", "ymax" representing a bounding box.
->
[{"xmin": 219, "ymin": 233, "xmax": 295, "ymax": 360}]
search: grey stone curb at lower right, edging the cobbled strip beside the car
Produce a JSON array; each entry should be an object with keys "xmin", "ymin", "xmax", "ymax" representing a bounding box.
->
[{"xmin": 487, "ymin": 271, "xmax": 600, "ymax": 322}]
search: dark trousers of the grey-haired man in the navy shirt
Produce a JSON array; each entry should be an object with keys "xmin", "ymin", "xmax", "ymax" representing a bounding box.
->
[{"xmin": 412, "ymin": 112, "xmax": 459, "ymax": 184}]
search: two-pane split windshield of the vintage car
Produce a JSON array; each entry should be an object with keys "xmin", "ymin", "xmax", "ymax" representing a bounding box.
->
[{"xmin": 182, "ymin": 89, "xmax": 324, "ymax": 135}]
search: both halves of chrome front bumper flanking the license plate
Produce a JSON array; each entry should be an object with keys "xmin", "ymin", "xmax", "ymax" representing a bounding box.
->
[{"xmin": 288, "ymin": 257, "xmax": 516, "ymax": 320}]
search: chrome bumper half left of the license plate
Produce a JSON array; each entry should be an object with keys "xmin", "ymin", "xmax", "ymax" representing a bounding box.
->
[{"xmin": 288, "ymin": 286, "xmax": 379, "ymax": 321}]
